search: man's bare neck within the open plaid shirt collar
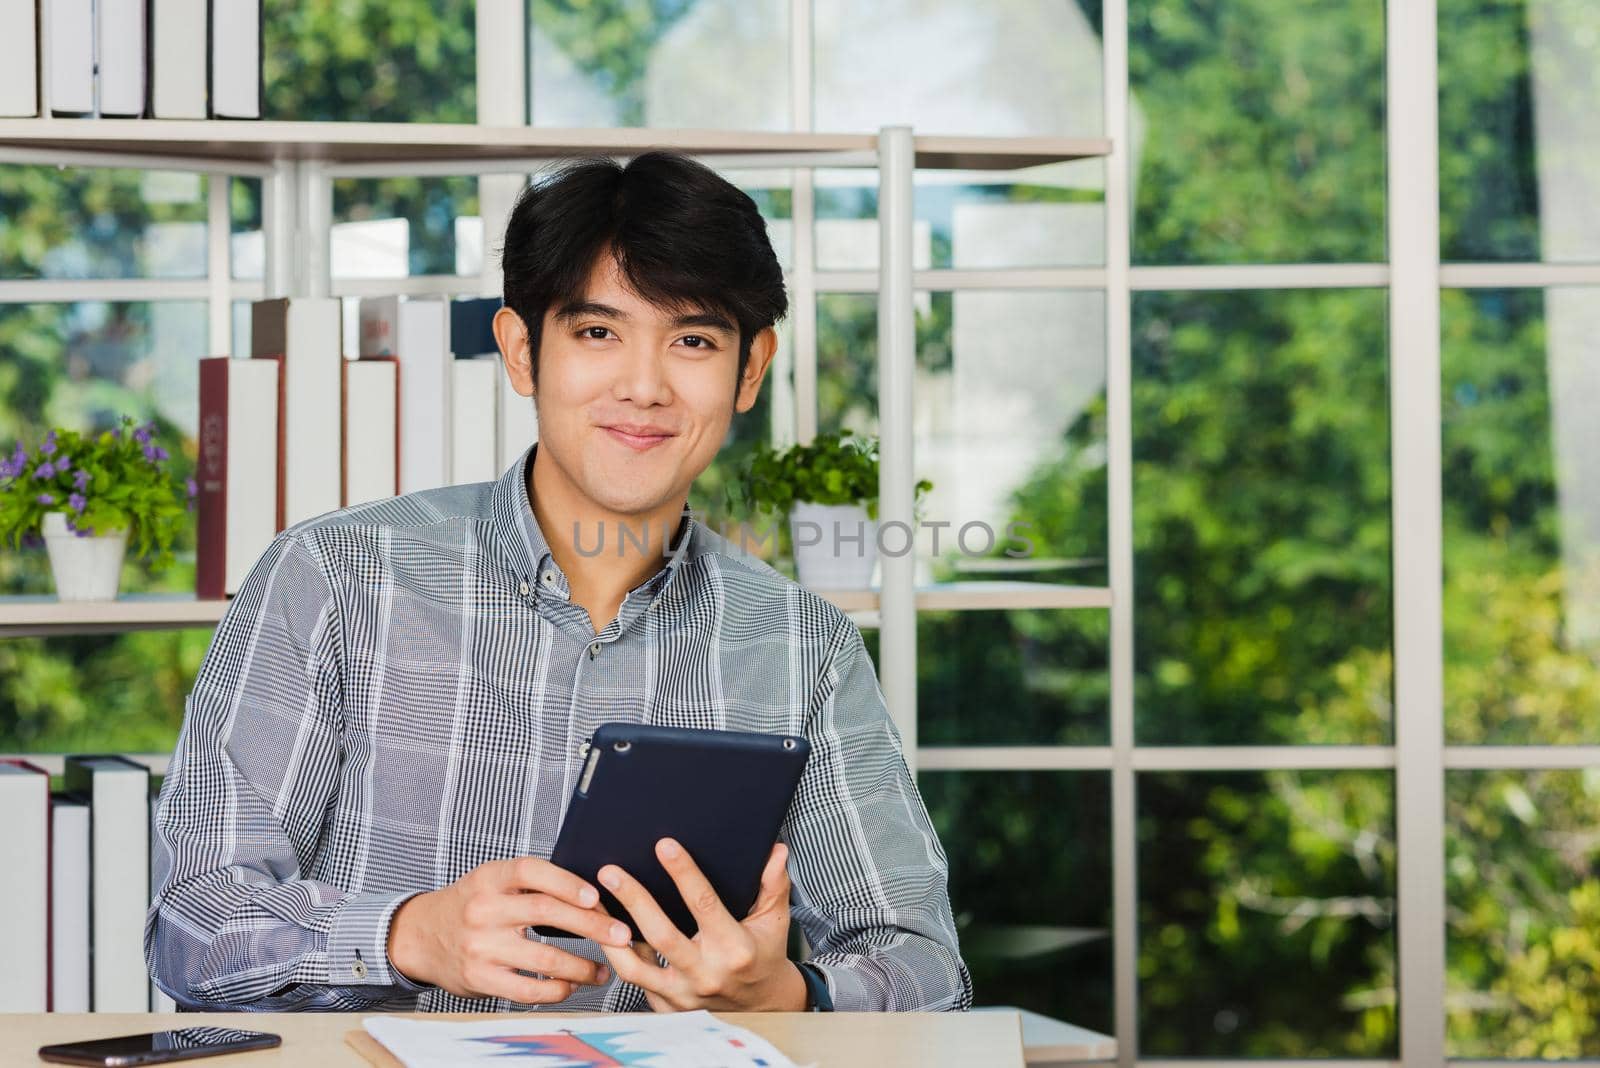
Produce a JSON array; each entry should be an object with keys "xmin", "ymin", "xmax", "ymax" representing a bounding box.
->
[{"xmin": 528, "ymin": 449, "xmax": 686, "ymax": 633}]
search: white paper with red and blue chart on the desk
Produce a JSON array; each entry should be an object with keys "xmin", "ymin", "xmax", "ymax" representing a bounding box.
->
[{"xmin": 362, "ymin": 1012, "xmax": 795, "ymax": 1068}]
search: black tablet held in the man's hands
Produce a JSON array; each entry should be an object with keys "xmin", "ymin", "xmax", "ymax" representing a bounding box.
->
[{"xmin": 534, "ymin": 723, "xmax": 811, "ymax": 940}]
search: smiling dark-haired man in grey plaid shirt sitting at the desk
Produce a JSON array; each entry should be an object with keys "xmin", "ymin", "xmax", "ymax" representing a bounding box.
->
[{"xmin": 146, "ymin": 152, "xmax": 971, "ymax": 1012}]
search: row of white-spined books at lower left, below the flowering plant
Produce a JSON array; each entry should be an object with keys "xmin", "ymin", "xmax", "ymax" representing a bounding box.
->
[{"xmin": 0, "ymin": 756, "xmax": 171, "ymax": 1012}]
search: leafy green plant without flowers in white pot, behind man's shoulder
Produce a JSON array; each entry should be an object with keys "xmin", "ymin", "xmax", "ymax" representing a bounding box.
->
[{"xmin": 739, "ymin": 430, "xmax": 933, "ymax": 590}]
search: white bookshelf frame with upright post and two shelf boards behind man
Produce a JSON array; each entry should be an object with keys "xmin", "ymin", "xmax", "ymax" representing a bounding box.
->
[{"xmin": 0, "ymin": 112, "xmax": 1112, "ymax": 753}]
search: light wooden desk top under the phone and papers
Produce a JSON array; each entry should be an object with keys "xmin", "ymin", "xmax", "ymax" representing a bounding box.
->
[{"xmin": 12, "ymin": 1012, "xmax": 1022, "ymax": 1068}]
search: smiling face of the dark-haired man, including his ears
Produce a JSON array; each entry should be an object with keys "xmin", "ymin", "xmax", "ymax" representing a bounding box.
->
[{"xmin": 496, "ymin": 256, "xmax": 776, "ymax": 515}]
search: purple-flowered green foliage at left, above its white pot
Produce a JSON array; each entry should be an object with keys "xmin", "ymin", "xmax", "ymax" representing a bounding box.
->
[{"xmin": 0, "ymin": 416, "xmax": 195, "ymax": 572}]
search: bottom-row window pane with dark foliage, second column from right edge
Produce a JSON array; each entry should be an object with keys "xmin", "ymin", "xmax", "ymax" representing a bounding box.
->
[{"xmin": 1138, "ymin": 771, "xmax": 1395, "ymax": 1058}]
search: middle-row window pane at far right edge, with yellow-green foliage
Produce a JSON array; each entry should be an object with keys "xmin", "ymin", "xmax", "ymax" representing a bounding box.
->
[{"xmin": 1440, "ymin": 288, "xmax": 1600, "ymax": 745}]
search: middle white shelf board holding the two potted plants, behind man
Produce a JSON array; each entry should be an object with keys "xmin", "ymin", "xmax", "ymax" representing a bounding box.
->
[{"xmin": 0, "ymin": 582, "xmax": 1110, "ymax": 638}]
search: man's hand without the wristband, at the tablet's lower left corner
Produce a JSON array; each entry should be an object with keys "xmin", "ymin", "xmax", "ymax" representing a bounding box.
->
[{"xmin": 389, "ymin": 857, "xmax": 632, "ymax": 1004}]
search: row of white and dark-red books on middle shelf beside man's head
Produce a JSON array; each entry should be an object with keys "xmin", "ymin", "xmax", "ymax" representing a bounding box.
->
[{"xmin": 195, "ymin": 297, "xmax": 539, "ymax": 598}]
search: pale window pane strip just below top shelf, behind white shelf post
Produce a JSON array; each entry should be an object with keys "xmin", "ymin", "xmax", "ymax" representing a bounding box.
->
[{"xmin": 816, "ymin": 160, "xmax": 1106, "ymax": 270}]
